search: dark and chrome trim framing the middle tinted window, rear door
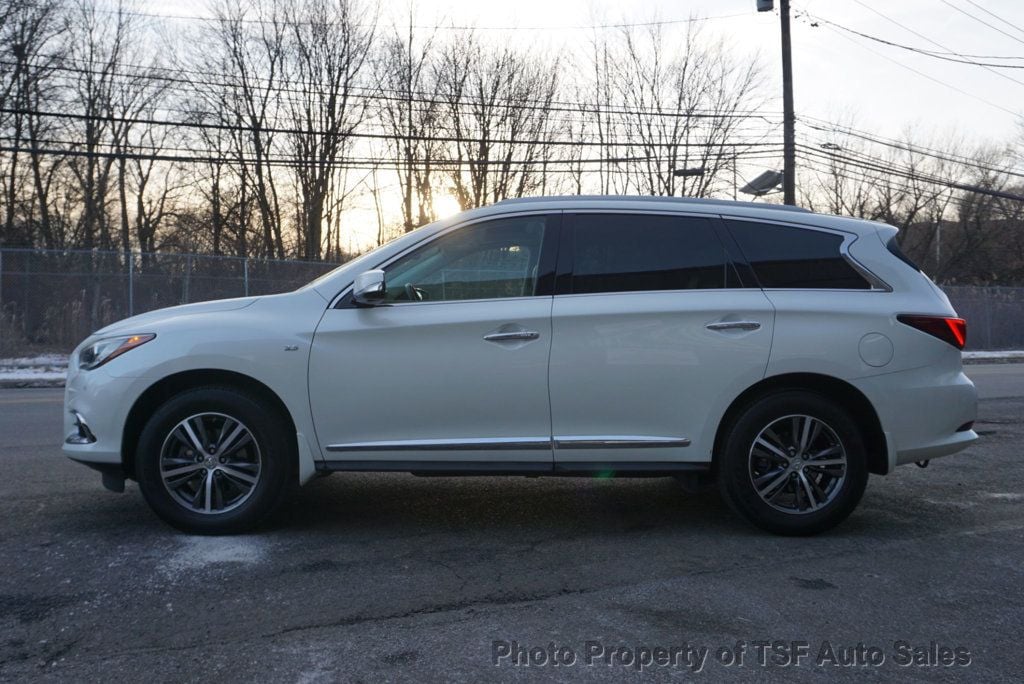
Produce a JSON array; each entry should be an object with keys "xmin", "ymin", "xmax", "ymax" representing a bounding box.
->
[{"xmin": 554, "ymin": 209, "xmax": 749, "ymax": 297}]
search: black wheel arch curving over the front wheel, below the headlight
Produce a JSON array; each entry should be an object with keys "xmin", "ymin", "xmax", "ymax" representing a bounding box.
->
[{"xmin": 121, "ymin": 369, "xmax": 296, "ymax": 478}]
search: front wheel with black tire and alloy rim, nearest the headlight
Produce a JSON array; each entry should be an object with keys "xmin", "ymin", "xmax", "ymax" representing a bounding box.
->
[{"xmin": 135, "ymin": 386, "xmax": 297, "ymax": 535}]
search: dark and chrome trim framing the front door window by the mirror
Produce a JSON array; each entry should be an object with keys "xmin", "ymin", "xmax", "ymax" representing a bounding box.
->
[{"xmin": 328, "ymin": 209, "xmax": 565, "ymax": 309}]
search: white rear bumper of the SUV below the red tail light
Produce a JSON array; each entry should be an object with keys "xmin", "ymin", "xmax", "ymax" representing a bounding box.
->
[{"xmin": 853, "ymin": 366, "xmax": 978, "ymax": 472}]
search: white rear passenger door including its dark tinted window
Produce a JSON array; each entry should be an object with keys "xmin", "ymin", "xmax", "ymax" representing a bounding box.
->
[{"xmin": 550, "ymin": 212, "xmax": 774, "ymax": 468}]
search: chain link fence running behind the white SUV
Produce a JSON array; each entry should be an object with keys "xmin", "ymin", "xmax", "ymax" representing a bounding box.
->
[{"xmin": 0, "ymin": 249, "xmax": 1024, "ymax": 356}]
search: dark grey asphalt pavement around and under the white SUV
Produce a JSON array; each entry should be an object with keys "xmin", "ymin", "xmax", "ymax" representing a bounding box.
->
[{"xmin": 0, "ymin": 365, "xmax": 1024, "ymax": 682}]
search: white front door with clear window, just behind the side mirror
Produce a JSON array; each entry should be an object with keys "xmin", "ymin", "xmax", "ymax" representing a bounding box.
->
[{"xmin": 309, "ymin": 214, "xmax": 560, "ymax": 469}]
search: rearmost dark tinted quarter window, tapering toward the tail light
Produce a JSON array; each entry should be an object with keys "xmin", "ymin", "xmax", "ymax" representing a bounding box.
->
[{"xmin": 727, "ymin": 220, "xmax": 870, "ymax": 290}]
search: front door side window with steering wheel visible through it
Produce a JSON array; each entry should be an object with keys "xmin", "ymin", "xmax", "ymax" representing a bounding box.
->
[{"xmin": 384, "ymin": 216, "xmax": 547, "ymax": 301}]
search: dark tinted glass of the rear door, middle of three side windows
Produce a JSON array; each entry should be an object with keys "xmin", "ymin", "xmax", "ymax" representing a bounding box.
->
[{"xmin": 572, "ymin": 214, "xmax": 735, "ymax": 293}]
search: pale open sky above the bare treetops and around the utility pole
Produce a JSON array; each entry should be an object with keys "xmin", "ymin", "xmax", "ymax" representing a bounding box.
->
[{"xmin": 138, "ymin": 0, "xmax": 1024, "ymax": 250}]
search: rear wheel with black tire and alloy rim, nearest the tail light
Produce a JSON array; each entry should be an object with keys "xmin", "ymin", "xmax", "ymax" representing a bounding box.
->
[{"xmin": 718, "ymin": 390, "xmax": 867, "ymax": 536}]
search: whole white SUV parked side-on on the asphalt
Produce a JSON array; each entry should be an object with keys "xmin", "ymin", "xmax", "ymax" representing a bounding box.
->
[{"xmin": 65, "ymin": 197, "xmax": 977, "ymax": 535}]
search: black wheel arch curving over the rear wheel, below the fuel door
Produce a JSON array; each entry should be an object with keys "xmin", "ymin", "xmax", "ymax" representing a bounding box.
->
[{"xmin": 712, "ymin": 373, "xmax": 889, "ymax": 475}]
